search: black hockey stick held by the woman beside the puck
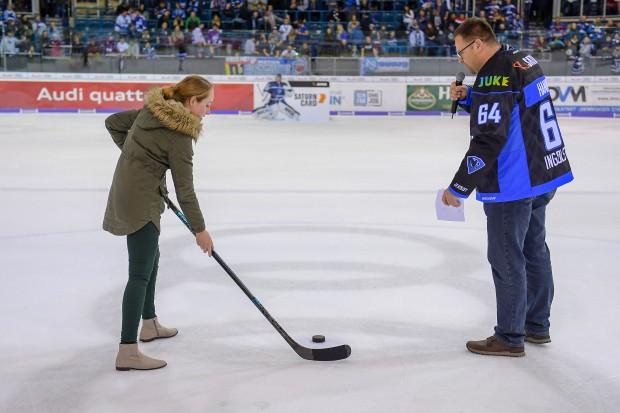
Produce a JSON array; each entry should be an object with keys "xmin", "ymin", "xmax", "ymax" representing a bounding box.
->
[{"xmin": 164, "ymin": 196, "xmax": 351, "ymax": 361}]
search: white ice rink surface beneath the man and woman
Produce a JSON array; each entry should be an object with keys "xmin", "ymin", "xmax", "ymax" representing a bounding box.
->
[{"xmin": 0, "ymin": 114, "xmax": 620, "ymax": 413}]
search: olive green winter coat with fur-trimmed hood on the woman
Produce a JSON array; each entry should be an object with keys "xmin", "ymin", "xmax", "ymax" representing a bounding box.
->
[{"xmin": 103, "ymin": 88, "xmax": 205, "ymax": 235}]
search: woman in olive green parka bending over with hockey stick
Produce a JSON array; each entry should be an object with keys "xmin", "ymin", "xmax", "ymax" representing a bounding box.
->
[{"xmin": 103, "ymin": 76, "xmax": 214, "ymax": 370}]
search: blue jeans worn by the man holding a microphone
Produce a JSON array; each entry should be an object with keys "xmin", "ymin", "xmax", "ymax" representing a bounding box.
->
[{"xmin": 484, "ymin": 190, "xmax": 555, "ymax": 346}]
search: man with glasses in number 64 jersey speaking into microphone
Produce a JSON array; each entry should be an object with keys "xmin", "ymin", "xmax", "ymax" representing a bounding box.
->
[{"xmin": 442, "ymin": 18, "xmax": 573, "ymax": 357}]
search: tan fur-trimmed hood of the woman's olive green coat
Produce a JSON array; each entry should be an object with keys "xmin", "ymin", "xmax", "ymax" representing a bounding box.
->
[{"xmin": 141, "ymin": 87, "xmax": 202, "ymax": 140}]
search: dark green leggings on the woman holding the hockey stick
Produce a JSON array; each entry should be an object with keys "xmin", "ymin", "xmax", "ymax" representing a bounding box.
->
[{"xmin": 121, "ymin": 222, "xmax": 159, "ymax": 344}]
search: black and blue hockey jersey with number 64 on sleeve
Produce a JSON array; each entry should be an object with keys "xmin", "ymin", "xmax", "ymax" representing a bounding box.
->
[{"xmin": 450, "ymin": 45, "xmax": 573, "ymax": 202}]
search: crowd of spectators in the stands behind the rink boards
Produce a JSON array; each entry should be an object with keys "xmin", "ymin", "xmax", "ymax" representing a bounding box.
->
[{"xmin": 0, "ymin": 0, "xmax": 620, "ymax": 68}]
